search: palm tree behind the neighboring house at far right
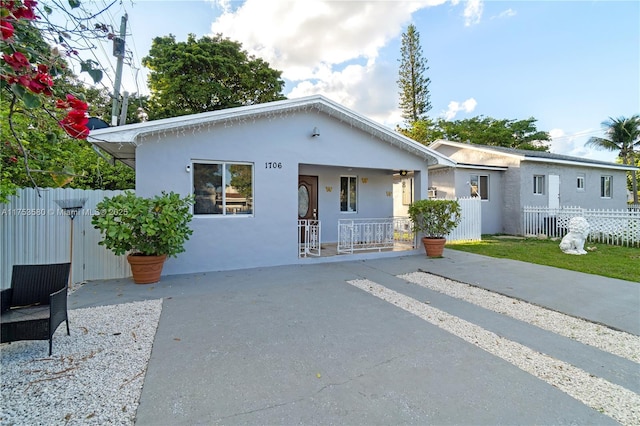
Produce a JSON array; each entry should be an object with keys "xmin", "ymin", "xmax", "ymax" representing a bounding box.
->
[{"xmin": 585, "ymin": 114, "xmax": 640, "ymax": 204}]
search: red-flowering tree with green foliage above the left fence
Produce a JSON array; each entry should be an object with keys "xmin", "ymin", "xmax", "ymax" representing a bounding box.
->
[{"xmin": 0, "ymin": 0, "xmax": 130, "ymax": 202}]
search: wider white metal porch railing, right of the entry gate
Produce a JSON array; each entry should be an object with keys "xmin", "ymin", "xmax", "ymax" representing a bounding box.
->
[{"xmin": 337, "ymin": 218, "xmax": 415, "ymax": 253}]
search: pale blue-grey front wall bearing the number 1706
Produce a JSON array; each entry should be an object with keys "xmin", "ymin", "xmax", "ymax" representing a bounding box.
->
[{"xmin": 136, "ymin": 112, "xmax": 436, "ymax": 274}]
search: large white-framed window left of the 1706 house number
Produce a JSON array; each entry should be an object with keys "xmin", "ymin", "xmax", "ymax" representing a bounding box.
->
[{"xmin": 193, "ymin": 162, "xmax": 253, "ymax": 216}]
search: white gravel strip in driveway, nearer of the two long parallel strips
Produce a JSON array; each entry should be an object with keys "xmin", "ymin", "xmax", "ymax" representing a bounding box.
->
[{"xmin": 348, "ymin": 280, "xmax": 640, "ymax": 425}]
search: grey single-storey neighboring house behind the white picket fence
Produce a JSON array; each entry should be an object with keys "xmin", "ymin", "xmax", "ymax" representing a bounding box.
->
[{"xmin": 429, "ymin": 140, "xmax": 636, "ymax": 235}]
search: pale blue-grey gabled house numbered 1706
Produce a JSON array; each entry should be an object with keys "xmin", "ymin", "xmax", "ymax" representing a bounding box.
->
[{"xmin": 89, "ymin": 96, "xmax": 455, "ymax": 274}]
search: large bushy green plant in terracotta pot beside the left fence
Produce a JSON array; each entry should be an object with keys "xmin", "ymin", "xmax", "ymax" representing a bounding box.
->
[{"xmin": 91, "ymin": 191, "xmax": 193, "ymax": 284}]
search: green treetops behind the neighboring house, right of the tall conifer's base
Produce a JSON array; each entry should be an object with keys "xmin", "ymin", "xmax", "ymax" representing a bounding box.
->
[{"xmin": 398, "ymin": 116, "xmax": 551, "ymax": 151}]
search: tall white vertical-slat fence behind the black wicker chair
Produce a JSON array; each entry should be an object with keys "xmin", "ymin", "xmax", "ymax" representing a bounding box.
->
[{"xmin": 0, "ymin": 188, "xmax": 131, "ymax": 288}]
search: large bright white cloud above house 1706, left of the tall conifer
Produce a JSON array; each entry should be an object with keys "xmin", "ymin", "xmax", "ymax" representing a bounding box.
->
[{"xmin": 211, "ymin": 0, "xmax": 456, "ymax": 124}]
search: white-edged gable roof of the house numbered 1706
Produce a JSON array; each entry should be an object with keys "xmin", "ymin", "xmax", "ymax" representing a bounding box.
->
[{"xmin": 87, "ymin": 95, "xmax": 456, "ymax": 168}]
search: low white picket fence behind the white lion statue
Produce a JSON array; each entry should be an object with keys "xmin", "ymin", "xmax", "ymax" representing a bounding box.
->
[{"xmin": 522, "ymin": 206, "xmax": 640, "ymax": 247}]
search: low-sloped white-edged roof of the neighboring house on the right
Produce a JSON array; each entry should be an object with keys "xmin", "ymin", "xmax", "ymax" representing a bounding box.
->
[{"xmin": 429, "ymin": 139, "xmax": 639, "ymax": 171}]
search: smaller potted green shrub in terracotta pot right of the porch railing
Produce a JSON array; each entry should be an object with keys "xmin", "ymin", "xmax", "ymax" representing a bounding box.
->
[{"xmin": 409, "ymin": 200, "xmax": 461, "ymax": 257}]
